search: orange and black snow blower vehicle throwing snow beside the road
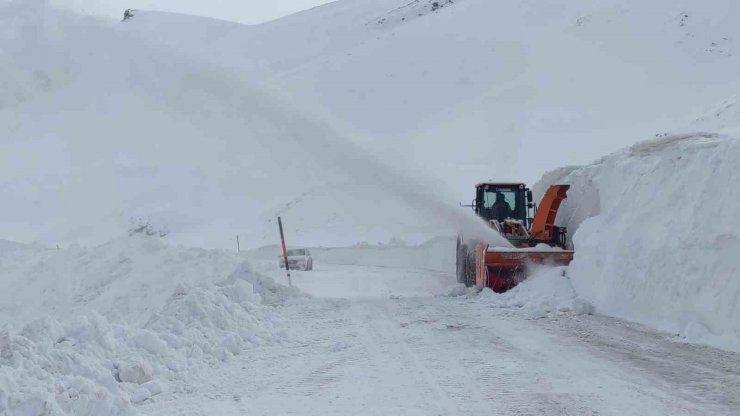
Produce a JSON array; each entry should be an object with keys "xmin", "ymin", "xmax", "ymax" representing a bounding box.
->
[{"xmin": 457, "ymin": 182, "xmax": 573, "ymax": 293}]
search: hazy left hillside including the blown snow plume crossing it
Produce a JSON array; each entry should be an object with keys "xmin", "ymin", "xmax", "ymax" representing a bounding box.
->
[{"xmin": 0, "ymin": 2, "xmax": 502, "ymax": 247}]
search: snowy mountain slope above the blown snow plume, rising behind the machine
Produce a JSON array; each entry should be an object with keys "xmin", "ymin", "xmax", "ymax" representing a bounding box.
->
[{"xmin": 126, "ymin": 0, "xmax": 740, "ymax": 190}]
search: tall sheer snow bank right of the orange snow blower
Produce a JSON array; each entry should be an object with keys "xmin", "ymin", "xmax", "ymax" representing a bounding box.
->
[{"xmin": 535, "ymin": 134, "xmax": 740, "ymax": 349}]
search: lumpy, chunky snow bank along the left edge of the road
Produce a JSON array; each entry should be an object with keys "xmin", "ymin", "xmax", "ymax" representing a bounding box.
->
[{"xmin": 0, "ymin": 264, "xmax": 285, "ymax": 416}]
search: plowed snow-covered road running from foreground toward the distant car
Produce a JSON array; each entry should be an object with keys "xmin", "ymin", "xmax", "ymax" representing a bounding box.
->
[{"xmin": 139, "ymin": 265, "xmax": 740, "ymax": 416}]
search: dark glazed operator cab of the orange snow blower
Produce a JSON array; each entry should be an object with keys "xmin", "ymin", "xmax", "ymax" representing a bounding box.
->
[{"xmin": 472, "ymin": 183, "xmax": 535, "ymax": 246}]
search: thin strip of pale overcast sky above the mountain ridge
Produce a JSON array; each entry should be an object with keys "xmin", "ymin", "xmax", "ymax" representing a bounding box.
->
[{"xmin": 51, "ymin": 0, "xmax": 336, "ymax": 24}]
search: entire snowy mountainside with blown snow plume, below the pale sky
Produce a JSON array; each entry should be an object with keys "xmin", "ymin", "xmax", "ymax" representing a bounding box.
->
[{"xmin": 0, "ymin": 0, "xmax": 740, "ymax": 247}]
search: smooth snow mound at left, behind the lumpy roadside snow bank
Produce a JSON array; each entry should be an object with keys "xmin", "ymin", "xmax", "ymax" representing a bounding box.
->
[{"xmin": 0, "ymin": 236, "xmax": 244, "ymax": 327}]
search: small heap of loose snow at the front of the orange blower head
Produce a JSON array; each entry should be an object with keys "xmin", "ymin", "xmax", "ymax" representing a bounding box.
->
[{"xmin": 478, "ymin": 267, "xmax": 593, "ymax": 319}]
